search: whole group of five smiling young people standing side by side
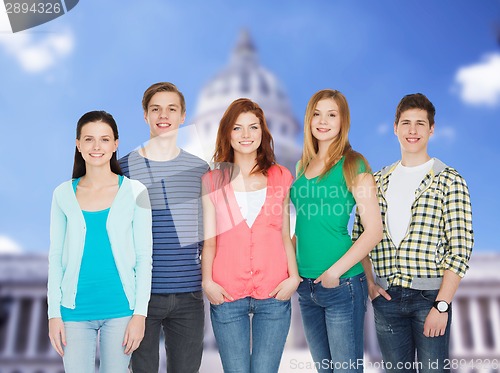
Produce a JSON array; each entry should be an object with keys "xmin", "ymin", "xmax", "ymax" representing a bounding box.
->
[{"xmin": 48, "ymin": 82, "xmax": 473, "ymax": 373}]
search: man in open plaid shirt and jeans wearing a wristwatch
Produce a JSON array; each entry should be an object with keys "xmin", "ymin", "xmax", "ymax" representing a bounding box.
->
[{"xmin": 352, "ymin": 93, "xmax": 474, "ymax": 373}]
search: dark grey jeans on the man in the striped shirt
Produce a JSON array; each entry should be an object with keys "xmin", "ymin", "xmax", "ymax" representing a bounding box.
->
[{"xmin": 132, "ymin": 291, "xmax": 205, "ymax": 373}]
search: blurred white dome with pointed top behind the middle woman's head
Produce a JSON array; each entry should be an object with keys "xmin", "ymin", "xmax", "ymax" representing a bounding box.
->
[{"xmin": 185, "ymin": 31, "xmax": 302, "ymax": 172}]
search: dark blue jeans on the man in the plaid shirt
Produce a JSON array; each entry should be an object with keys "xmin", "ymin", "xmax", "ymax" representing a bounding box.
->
[{"xmin": 372, "ymin": 286, "xmax": 451, "ymax": 373}]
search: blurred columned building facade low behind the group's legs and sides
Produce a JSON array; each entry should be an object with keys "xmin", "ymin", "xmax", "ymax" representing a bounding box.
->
[{"xmin": 0, "ymin": 254, "xmax": 500, "ymax": 373}]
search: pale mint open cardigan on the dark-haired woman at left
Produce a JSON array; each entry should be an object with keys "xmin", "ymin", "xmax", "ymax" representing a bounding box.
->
[{"xmin": 47, "ymin": 177, "xmax": 153, "ymax": 319}]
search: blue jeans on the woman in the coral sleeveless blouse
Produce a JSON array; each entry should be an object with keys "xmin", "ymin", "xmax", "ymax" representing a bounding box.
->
[{"xmin": 210, "ymin": 297, "xmax": 291, "ymax": 373}]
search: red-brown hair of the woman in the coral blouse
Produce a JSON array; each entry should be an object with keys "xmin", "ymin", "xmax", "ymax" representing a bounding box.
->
[{"xmin": 213, "ymin": 98, "xmax": 276, "ymax": 175}]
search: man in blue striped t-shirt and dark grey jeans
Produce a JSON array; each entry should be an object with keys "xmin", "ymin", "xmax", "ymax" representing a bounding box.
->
[{"xmin": 119, "ymin": 82, "xmax": 208, "ymax": 373}]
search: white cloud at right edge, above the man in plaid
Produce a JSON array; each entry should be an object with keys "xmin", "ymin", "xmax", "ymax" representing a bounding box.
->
[{"xmin": 455, "ymin": 53, "xmax": 500, "ymax": 106}]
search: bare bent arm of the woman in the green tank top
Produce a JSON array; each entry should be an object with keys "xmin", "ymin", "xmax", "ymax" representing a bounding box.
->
[{"xmin": 315, "ymin": 173, "xmax": 383, "ymax": 288}]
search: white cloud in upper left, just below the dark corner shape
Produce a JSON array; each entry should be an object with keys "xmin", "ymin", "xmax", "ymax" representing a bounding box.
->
[{"xmin": 0, "ymin": 30, "xmax": 74, "ymax": 73}]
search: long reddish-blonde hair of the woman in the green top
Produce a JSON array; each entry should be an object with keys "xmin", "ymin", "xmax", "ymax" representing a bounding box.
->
[{"xmin": 297, "ymin": 89, "xmax": 371, "ymax": 189}]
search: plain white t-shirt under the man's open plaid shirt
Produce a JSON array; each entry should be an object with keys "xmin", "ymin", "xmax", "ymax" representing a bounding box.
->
[{"xmin": 386, "ymin": 159, "xmax": 434, "ymax": 246}]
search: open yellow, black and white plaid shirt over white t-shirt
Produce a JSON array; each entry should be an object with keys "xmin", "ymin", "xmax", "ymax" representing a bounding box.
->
[{"xmin": 352, "ymin": 159, "xmax": 474, "ymax": 288}]
